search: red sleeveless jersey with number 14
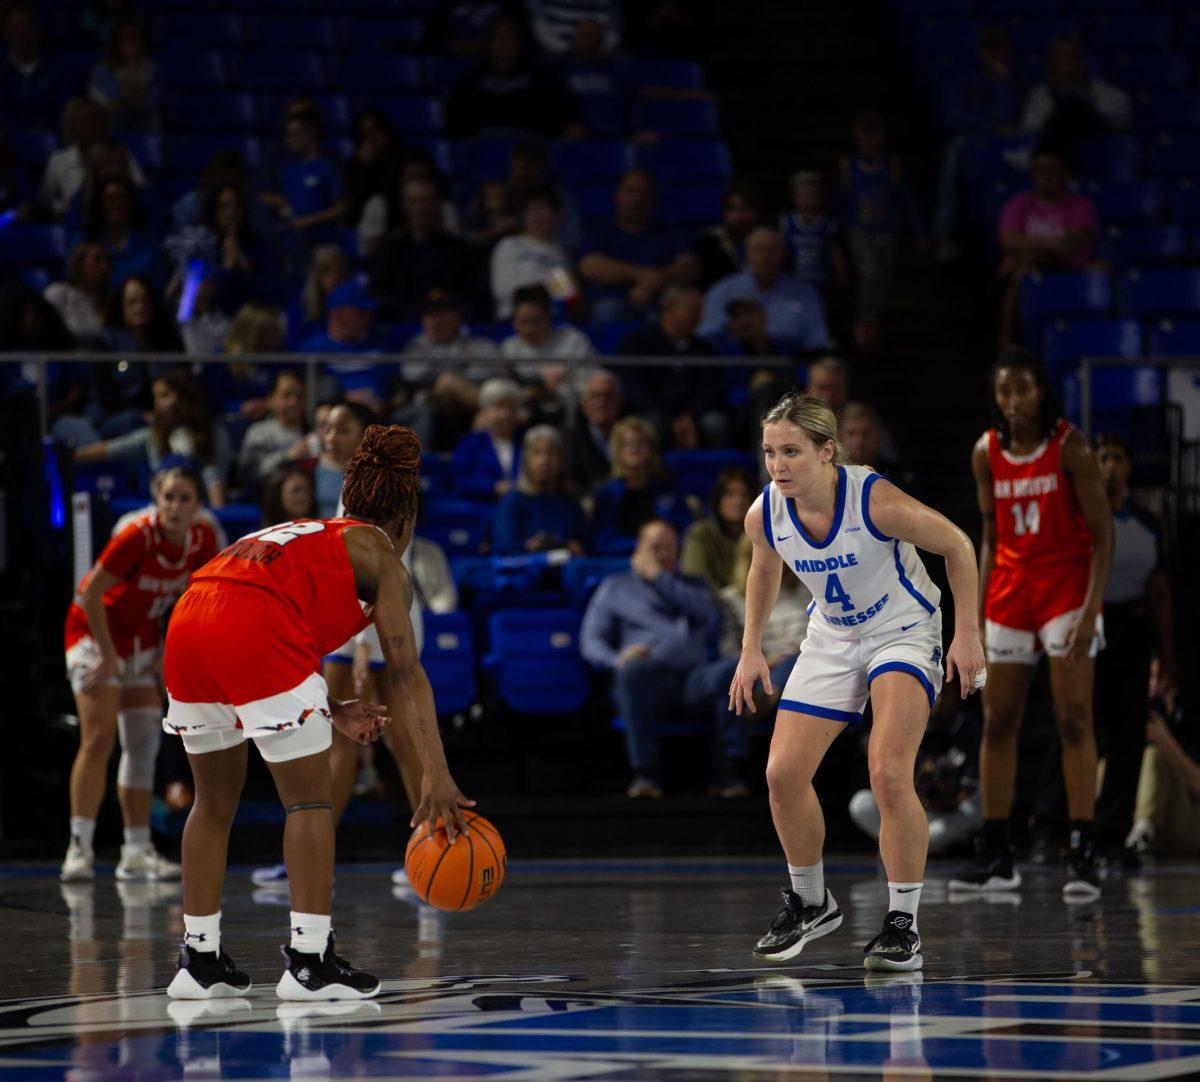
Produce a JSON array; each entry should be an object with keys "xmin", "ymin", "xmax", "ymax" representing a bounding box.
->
[{"xmin": 988, "ymin": 419, "xmax": 1092, "ymax": 570}]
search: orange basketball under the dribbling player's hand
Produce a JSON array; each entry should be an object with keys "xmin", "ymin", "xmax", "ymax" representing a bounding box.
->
[{"xmin": 404, "ymin": 811, "xmax": 506, "ymax": 910}]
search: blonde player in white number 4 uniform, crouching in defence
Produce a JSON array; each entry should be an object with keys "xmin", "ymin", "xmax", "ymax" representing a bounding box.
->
[{"xmin": 730, "ymin": 395, "xmax": 984, "ymax": 972}]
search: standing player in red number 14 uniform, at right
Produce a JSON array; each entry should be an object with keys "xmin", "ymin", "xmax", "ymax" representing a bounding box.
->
[{"xmin": 949, "ymin": 349, "xmax": 1112, "ymax": 901}]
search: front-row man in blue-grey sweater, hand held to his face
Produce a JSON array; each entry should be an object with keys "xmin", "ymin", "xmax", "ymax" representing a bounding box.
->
[{"xmin": 580, "ymin": 519, "xmax": 749, "ymax": 799}]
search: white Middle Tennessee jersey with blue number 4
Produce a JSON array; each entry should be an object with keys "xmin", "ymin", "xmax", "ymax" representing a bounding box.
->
[{"xmin": 762, "ymin": 465, "xmax": 942, "ymax": 639}]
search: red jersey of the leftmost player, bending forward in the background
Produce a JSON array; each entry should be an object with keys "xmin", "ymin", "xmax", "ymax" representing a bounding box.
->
[{"xmin": 64, "ymin": 511, "xmax": 217, "ymax": 657}]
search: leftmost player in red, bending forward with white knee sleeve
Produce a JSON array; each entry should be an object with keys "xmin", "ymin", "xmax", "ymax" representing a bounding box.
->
[{"xmin": 60, "ymin": 467, "xmax": 217, "ymax": 883}]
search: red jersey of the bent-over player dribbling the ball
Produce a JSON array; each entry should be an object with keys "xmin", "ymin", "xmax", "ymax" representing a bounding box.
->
[{"xmin": 193, "ymin": 518, "xmax": 382, "ymax": 655}]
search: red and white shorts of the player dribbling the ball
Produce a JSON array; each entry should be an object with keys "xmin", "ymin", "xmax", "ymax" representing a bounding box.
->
[{"xmin": 162, "ymin": 583, "xmax": 334, "ymax": 763}]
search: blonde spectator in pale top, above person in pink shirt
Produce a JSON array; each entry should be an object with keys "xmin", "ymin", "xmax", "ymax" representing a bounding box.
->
[{"xmin": 1021, "ymin": 36, "xmax": 1133, "ymax": 154}]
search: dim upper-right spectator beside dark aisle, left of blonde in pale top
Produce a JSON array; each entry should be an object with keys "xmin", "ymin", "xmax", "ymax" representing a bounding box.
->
[{"xmin": 934, "ymin": 24, "xmax": 1022, "ymax": 263}]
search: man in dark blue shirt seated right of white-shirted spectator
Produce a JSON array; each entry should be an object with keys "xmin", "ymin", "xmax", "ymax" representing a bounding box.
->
[{"xmin": 580, "ymin": 169, "xmax": 695, "ymax": 323}]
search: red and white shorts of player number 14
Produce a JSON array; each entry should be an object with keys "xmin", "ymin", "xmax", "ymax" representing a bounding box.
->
[{"xmin": 984, "ymin": 560, "xmax": 1104, "ymax": 665}]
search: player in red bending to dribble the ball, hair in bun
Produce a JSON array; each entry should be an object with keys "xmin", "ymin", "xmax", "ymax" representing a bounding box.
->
[{"xmin": 163, "ymin": 425, "xmax": 472, "ymax": 999}]
